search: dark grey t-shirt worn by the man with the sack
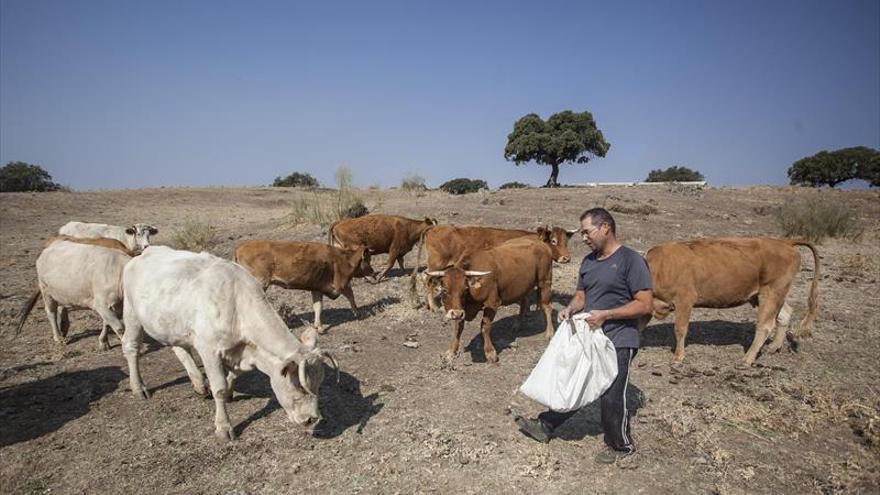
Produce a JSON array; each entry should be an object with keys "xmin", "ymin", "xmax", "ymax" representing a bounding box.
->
[{"xmin": 577, "ymin": 246, "xmax": 652, "ymax": 349}]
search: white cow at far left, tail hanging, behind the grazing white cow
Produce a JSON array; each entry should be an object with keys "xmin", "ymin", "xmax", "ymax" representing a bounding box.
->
[{"xmin": 16, "ymin": 238, "xmax": 132, "ymax": 350}]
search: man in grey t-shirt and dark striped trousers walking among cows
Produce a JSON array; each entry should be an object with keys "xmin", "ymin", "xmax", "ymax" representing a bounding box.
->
[{"xmin": 514, "ymin": 208, "xmax": 654, "ymax": 464}]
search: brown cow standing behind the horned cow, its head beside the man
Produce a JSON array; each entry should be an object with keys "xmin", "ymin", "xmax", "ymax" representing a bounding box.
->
[{"xmin": 410, "ymin": 225, "xmax": 577, "ymax": 311}]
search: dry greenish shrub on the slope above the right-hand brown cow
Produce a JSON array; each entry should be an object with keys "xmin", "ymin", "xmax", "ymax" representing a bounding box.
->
[{"xmin": 776, "ymin": 197, "xmax": 863, "ymax": 242}]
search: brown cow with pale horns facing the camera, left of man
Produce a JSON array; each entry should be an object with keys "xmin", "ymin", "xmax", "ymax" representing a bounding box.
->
[{"xmin": 426, "ymin": 237, "xmax": 553, "ymax": 363}]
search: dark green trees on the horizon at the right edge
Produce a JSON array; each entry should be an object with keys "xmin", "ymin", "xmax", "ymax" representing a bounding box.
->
[{"xmin": 788, "ymin": 146, "xmax": 880, "ymax": 187}]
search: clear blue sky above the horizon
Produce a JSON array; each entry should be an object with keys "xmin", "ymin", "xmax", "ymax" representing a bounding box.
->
[{"xmin": 0, "ymin": 0, "xmax": 880, "ymax": 189}]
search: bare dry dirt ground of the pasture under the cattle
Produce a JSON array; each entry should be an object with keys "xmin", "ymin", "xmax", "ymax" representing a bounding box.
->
[{"xmin": 0, "ymin": 186, "xmax": 880, "ymax": 494}]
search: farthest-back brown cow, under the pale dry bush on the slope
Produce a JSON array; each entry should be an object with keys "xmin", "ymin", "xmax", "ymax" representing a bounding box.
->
[{"xmin": 327, "ymin": 215, "xmax": 437, "ymax": 282}]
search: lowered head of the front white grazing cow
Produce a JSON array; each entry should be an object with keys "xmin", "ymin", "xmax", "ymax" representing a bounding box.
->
[{"xmin": 269, "ymin": 328, "xmax": 339, "ymax": 426}]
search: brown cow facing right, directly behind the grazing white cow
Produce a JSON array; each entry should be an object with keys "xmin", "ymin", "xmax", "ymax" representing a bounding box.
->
[{"xmin": 234, "ymin": 240, "xmax": 373, "ymax": 333}]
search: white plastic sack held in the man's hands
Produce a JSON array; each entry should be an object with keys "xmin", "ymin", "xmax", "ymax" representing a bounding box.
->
[{"xmin": 519, "ymin": 313, "xmax": 617, "ymax": 412}]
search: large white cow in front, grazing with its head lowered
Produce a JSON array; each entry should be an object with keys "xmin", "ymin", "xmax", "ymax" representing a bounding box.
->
[{"xmin": 122, "ymin": 246, "xmax": 338, "ymax": 440}]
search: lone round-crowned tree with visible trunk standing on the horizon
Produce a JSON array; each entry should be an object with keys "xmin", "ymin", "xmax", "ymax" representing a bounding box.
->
[{"xmin": 504, "ymin": 110, "xmax": 611, "ymax": 187}]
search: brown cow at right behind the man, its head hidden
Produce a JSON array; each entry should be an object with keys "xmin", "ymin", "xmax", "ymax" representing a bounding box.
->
[{"xmin": 644, "ymin": 238, "xmax": 819, "ymax": 366}]
